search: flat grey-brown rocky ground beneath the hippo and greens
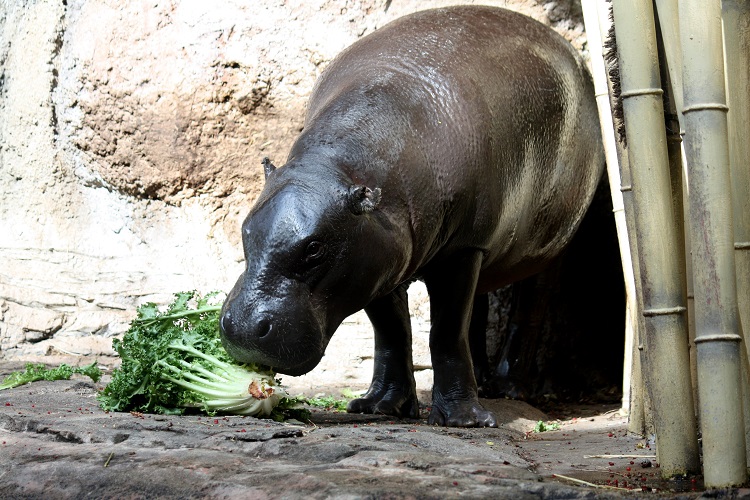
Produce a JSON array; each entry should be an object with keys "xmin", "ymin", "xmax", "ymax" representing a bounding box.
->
[{"xmin": 0, "ymin": 362, "xmax": 750, "ymax": 499}]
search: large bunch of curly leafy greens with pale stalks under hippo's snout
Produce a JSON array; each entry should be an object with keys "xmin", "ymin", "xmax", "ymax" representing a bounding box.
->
[{"xmin": 98, "ymin": 292, "xmax": 297, "ymax": 418}]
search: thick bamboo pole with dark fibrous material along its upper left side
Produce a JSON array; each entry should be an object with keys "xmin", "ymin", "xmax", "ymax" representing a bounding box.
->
[{"xmin": 613, "ymin": 0, "xmax": 699, "ymax": 477}]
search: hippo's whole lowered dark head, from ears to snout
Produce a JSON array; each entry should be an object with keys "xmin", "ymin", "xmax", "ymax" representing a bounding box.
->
[{"xmin": 220, "ymin": 158, "xmax": 402, "ymax": 375}]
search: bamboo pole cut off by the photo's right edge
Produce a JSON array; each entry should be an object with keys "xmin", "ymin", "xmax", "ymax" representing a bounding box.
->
[{"xmin": 722, "ymin": 0, "xmax": 750, "ymax": 467}]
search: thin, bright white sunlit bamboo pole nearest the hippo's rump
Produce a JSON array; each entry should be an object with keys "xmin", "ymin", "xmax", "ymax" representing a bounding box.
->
[{"xmin": 581, "ymin": 0, "xmax": 638, "ymax": 422}]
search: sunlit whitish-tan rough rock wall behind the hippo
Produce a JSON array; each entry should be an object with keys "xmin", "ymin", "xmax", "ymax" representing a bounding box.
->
[{"xmin": 0, "ymin": 0, "xmax": 585, "ymax": 386}]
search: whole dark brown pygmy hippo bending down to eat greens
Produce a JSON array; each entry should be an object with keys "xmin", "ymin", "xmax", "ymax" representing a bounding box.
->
[{"xmin": 221, "ymin": 6, "xmax": 603, "ymax": 426}]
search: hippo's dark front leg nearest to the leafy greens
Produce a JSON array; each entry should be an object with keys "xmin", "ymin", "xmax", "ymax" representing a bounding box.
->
[{"xmin": 347, "ymin": 284, "xmax": 419, "ymax": 418}]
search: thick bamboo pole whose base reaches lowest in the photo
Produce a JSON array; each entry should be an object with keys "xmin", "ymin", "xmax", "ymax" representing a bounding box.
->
[{"xmin": 679, "ymin": 0, "xmax": 747, "ymax": 487}]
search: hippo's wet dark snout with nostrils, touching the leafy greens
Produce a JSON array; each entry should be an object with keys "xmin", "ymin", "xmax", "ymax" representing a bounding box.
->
[{"xmin": 219, "ymin": 292, "xmax": 326, "ymax": 375}]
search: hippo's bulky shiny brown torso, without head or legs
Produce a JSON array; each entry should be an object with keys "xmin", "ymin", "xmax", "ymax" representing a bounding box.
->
[{"xmin": 290, "ymin": 6, "xmax": 603, "ymax": 290}]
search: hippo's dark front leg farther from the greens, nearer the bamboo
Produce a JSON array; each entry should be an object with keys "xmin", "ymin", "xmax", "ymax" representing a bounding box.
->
[{"xmin": 425, "ymin": 249, "xmax": 497, "ymax": 427}]
